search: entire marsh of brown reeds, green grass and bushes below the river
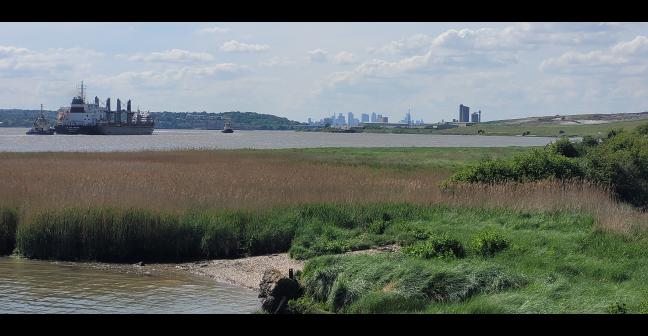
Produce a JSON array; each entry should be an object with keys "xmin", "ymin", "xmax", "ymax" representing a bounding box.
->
[{"xmin": 0, "ymin": 125, "xmax": 648, "ymax": 313}]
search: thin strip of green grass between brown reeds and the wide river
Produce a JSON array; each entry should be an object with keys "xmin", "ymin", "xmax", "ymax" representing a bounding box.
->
[{"xmin": 272, "ymin": 147, "xmax": 529, "ymax": 171}]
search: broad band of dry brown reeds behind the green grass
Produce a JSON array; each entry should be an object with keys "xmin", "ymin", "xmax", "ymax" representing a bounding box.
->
[{"xmin": 0, "ymin": 151, "xmax": 648, "ymax": 233}]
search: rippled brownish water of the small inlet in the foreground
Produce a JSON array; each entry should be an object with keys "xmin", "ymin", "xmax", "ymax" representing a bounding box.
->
[{"xmin": 0, "ymin": 257, "xmax": 261, "ymax": 314}]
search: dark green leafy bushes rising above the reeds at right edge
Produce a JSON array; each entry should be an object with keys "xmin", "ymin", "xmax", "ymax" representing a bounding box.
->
[{"xmin": 446, "ymin": 124, "xmax": 648, "ymax": 209}]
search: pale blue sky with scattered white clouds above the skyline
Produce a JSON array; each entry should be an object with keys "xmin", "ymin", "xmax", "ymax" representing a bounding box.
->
[{"xmin": 0, "ymin": 22, "xmax": 648, "ymax": 122}]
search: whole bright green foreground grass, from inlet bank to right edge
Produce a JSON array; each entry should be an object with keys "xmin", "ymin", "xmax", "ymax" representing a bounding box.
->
[{"xmin": 3, "ymin": 204, "xmax": 648, "ymax": 313}]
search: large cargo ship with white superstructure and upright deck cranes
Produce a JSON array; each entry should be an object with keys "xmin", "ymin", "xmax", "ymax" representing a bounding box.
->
[{"xmin": 54, "ymin": 82, "xmax": 155, "ymax": 135}]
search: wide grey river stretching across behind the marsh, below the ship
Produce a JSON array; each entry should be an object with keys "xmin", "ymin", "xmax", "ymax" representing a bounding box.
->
[{"xmin": 0, "ymin": 128, "xmax": 555, "ymax": 152}]
